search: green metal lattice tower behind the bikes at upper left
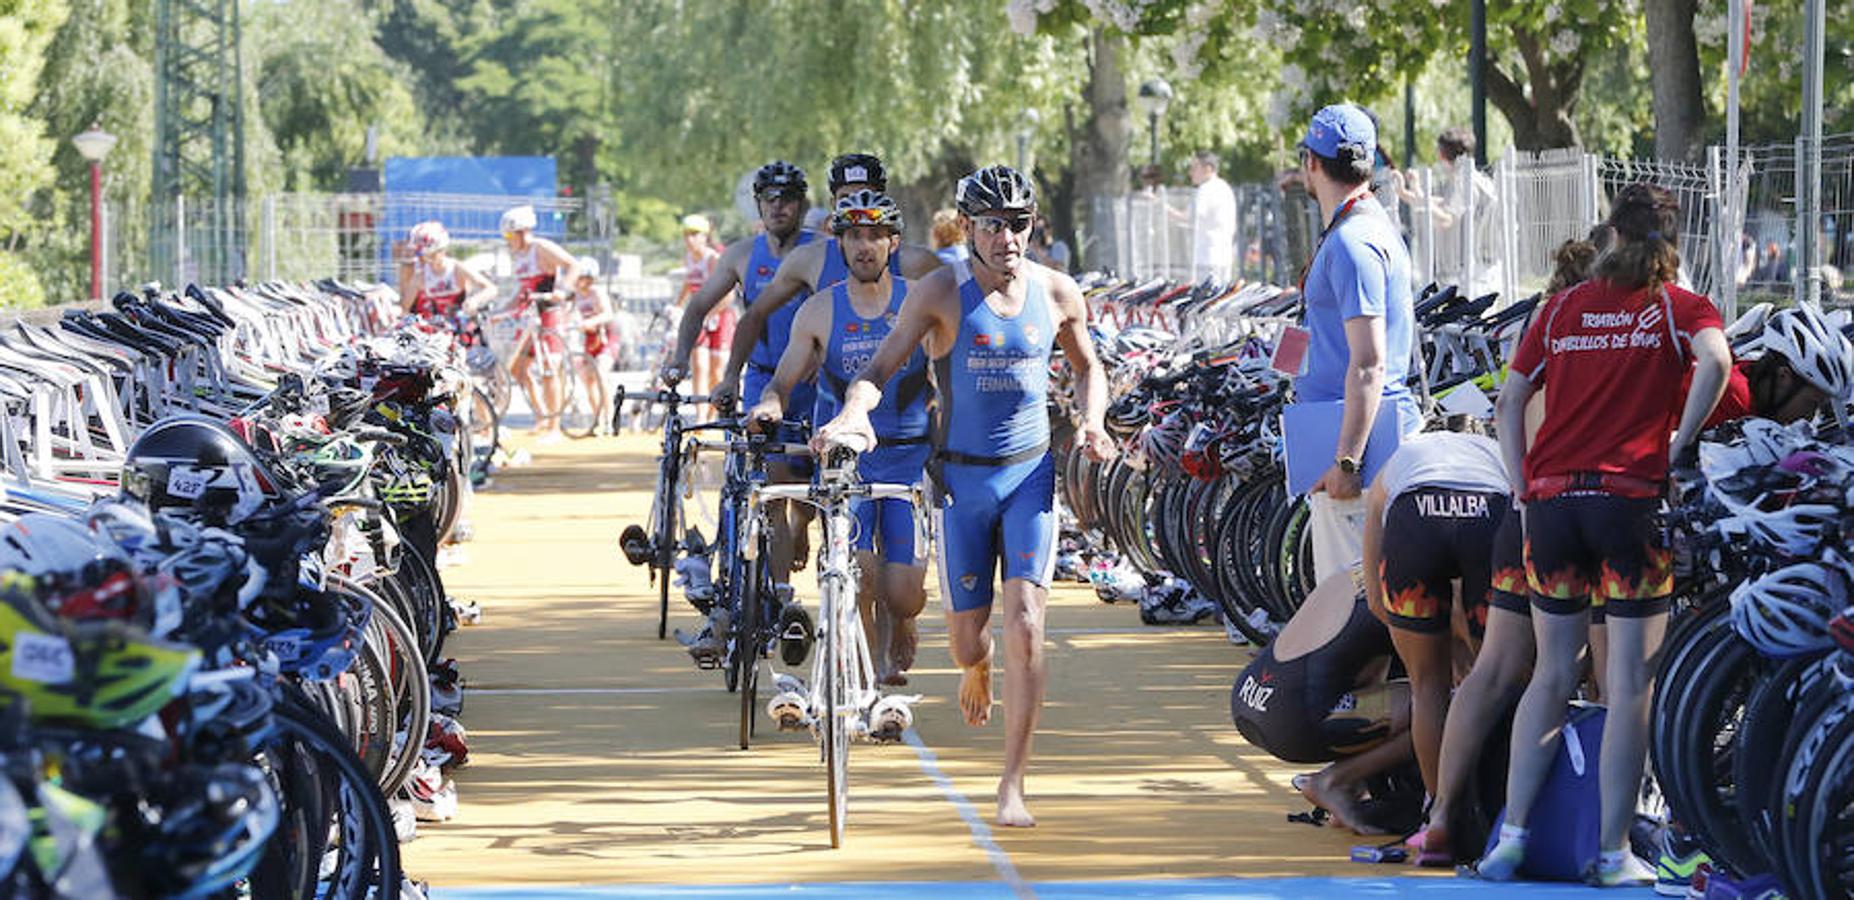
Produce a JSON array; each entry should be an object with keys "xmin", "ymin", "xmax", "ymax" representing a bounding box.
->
[{"xmin": 148, "ymin": 0, "xmax": 245, "ymax": 286}]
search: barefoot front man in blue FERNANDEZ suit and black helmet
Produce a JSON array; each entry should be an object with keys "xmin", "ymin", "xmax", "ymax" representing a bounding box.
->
[{"xmin": 812, "ymin": 165, "xmax": 1114, "ymax": 828}]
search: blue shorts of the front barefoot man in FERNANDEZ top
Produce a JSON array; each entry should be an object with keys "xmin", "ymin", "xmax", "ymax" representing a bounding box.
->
[{"xmin": 934, "ymin": 453, "xmax": 1057, "ymax": 612}]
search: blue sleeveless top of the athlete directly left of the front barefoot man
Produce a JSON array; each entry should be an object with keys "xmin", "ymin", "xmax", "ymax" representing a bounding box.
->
[{"xmin": 812, "ymin": 278, "xmax": 927, "ymax": 444}]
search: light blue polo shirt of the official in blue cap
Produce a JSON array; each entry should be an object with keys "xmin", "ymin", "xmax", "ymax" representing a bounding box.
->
[{"xmin": 1294, "ymin": 197, "xmax": 1415, "ymax": 401}]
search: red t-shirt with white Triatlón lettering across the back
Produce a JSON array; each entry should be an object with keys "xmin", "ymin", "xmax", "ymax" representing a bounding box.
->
[{"xmin": 1511, "ymin": 278, "xmax": 1724, "ymax": 482}]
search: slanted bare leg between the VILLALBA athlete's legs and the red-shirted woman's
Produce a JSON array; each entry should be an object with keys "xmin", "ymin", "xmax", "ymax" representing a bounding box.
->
[{"xmin": 1424, "ymin": 607, "xmax": 1533, "ymax": 850}]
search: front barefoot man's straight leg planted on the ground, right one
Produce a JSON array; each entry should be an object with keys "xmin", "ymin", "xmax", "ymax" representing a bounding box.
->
[{"xmin": 997, "ymin": 579, "xmax": 1049, "ymax": 828}]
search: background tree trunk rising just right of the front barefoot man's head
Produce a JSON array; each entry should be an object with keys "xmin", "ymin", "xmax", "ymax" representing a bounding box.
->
[{"xmin": 1068, "ymin": 28, "xmax": 1133, "ymax": 271}]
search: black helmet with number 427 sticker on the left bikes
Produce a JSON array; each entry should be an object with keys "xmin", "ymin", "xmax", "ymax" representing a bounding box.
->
[{"xmin": 122, "ymin": 416, "xmax": 287, "ymax": 525}]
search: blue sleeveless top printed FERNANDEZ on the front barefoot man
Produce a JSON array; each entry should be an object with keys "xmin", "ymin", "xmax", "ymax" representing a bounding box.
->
[{"xmin": 934, "ymin": 262, "xmax": 1055, "ymax": 462}]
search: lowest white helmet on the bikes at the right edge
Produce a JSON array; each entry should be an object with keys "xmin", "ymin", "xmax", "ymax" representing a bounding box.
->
[{"xmin": 1732, "ymin": 562, "xmax": 1848, "ymax": 659}]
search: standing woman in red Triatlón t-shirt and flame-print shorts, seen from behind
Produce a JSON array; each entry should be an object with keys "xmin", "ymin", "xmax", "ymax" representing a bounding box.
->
[{"xmin": 1479, "ymin": 184, "xmax": 1732, "ymax": 885}]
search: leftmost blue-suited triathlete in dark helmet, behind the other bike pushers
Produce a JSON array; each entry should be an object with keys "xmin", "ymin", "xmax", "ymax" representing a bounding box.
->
[{"xmin": 662, "ymin": 160, "xmax": 818, "ymax": 661}]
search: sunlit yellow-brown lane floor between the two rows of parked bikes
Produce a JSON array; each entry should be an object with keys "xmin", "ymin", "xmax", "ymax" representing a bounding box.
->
[{"xmin": 406, "ymin": 436, "xmax": 1423, "ymax": 889}]
